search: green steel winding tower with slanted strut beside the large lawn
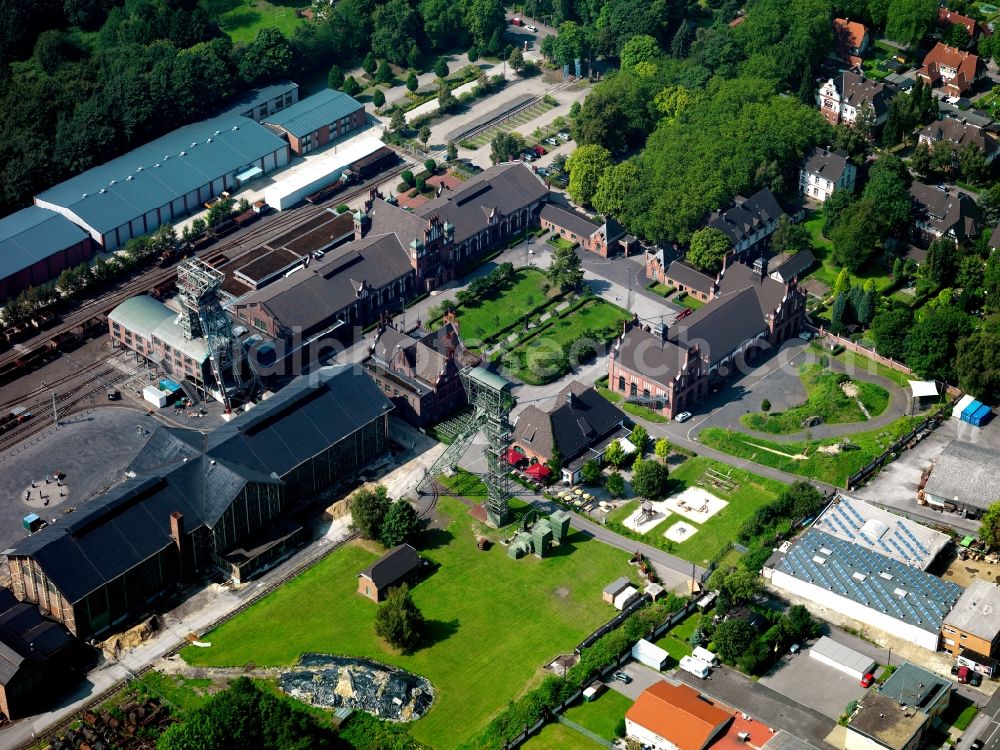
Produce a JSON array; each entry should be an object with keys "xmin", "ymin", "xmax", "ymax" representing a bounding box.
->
[{"xmin": 417, "ymin": 367, "xmax": 514, "ymax": 528}]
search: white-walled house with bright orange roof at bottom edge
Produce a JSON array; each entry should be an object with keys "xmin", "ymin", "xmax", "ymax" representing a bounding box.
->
[{"xmin": 625, "ymin": 681, "xmax": 733, "ymax": 750}]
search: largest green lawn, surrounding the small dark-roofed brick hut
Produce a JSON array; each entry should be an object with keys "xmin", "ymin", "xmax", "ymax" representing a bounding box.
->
[{"xmin": 182, "ymin": 498, "xmax": 630, "ymax": 749}]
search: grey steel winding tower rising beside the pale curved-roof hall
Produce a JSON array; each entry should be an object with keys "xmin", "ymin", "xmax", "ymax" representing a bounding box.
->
[{"xmin": 177, "ymin": 258, "xmax": 260, "ymax": 412}]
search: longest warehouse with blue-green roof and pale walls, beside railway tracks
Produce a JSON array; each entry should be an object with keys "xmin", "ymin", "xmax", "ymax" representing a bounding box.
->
[{"xmin": 35, "ymin": 114, "xmax": 289, "ymax": 250}]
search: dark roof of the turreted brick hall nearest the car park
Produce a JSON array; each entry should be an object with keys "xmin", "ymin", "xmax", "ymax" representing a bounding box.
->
[{"xmin": 416, "ymin": 162, "xmax": 548, "ymax": 243}]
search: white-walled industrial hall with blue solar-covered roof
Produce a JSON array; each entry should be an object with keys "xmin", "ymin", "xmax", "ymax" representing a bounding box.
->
[{"xmin": 763, "ymin": 529, "xmax": 962, "ymax": 651}]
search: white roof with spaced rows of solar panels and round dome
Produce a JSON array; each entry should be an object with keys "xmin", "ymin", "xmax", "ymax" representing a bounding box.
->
[{"xmin": 812, "ymin": 495, "xmax": 949, "ymax": 570}]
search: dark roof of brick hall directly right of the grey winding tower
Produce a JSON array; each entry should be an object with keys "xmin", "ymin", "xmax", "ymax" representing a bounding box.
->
[{"xmin": 239, "ymin": 234, "xmax": 413, "ymax": 335}]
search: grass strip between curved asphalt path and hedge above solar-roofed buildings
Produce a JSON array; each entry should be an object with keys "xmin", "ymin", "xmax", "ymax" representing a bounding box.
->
[{"xmin": 698, "ymin": 417, "xmax": 919, "ymax": 487}]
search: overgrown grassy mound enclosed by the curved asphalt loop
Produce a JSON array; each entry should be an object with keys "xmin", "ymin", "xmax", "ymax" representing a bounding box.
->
[{"xmin": 740, "ymin": 364, "xmax": 889, "ymax": 435}]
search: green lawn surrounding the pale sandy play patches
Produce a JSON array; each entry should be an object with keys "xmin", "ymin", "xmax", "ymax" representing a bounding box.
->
[{"xmin": 607, "ymin": 456, "xmax": 784, "ymax": 564}]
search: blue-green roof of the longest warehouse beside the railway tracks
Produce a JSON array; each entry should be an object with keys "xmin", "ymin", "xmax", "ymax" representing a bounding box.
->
[{"xmin": 35, "ymin": 115, "xmax": 288, "ymax": 232}]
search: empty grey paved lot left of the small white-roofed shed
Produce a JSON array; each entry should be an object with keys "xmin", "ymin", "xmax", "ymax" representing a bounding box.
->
[{"xmin": 760, "ymin": 649, "xmax": 866, "ymax": 720}]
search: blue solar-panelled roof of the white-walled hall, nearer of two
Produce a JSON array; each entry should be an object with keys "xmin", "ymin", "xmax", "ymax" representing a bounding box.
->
[{"xmin": 775, "ymin": 529, "xmax": 962, "ymax": 632}]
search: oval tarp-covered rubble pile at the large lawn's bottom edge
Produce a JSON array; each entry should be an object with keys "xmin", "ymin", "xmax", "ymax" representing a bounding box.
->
[{"xmin": 278, "ymin": 654, "xmax": 434, "ymax": 721}]
